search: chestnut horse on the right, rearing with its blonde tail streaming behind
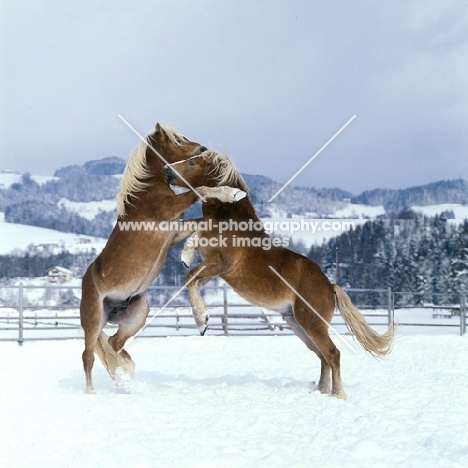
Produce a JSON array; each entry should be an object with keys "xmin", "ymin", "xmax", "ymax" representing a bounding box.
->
[{"xmin": 165, "ymin": 151, "xmax": 394, "ymax": 399}]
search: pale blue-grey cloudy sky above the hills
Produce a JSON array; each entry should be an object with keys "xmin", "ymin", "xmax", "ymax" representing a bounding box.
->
[{"xmin": 0, "ymin": 0, "xmax": 468, "ymax": 194}]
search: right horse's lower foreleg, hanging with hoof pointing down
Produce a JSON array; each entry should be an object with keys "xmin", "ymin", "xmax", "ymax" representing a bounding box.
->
[{"xmin": 185, "ymin": 256, "xmax": 221, "ymax": 336}]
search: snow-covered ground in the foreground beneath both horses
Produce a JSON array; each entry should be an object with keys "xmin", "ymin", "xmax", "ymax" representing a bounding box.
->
[{"xmin": 0, "ymin": 335, "xmax": 468, "ymax": 468}]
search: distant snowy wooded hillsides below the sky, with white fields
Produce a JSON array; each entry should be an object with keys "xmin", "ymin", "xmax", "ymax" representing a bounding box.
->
[{"xmin": 0, "ymin": 157, "xmax": 468, "ymax": 260}]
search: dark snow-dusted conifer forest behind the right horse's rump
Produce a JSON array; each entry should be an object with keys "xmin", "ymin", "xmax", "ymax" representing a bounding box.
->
[{"xmin": 307, "ymin": 212, "xmax": 468, "ymax": 305}]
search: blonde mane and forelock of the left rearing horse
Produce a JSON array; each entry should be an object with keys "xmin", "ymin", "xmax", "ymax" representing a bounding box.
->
[{"xmin": 116, "ymin": 126, "xmax": 188, "ymax": 216}]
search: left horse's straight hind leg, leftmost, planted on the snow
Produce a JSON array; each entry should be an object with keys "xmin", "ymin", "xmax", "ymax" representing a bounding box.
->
[{"xmin": 80, "ymin": 273, "xmax": 105, "ymax": 393}]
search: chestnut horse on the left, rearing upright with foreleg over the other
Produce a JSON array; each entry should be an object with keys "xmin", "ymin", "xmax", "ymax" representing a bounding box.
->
[{"xmin": 80, "ymin": 123, "xmax": 242, "ymax": 393}]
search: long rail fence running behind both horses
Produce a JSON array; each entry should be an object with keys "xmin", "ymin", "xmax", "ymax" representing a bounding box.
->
[{"xmin": 0, "ymin": 282, "xmax": 466, "ymax": 345}]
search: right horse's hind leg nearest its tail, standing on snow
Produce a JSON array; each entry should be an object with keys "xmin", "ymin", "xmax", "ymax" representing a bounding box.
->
[{"xmin": 294, "ymin": 304, "xmax": 346, "ymax": 400}]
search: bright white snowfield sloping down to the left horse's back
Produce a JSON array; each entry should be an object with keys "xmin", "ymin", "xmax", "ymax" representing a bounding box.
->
[{"xmin": 0, "ymin": 213, "xmax": 106, "ymax": 255}]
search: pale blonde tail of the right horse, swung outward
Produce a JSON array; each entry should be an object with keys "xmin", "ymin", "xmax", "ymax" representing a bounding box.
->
[{"xmin": 333, "ymin": 284, "xmax": 395, "ymax": 357}]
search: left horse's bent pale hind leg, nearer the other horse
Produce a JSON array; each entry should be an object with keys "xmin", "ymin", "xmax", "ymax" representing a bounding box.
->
[{"xmin": 106, "ymin": 295, "xmax": 149, "ymax": 378}]
